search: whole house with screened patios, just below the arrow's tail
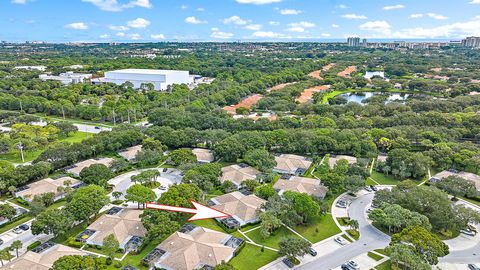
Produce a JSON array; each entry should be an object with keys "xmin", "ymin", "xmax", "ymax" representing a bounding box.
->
[{"xmin": 76, "ymin": 207, "xmax": 147, "ymax": 251}]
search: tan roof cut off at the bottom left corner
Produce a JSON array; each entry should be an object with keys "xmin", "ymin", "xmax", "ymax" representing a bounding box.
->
[{"xmin": 2, "ymin": 244, "xmax": 87, "ymax": 270}]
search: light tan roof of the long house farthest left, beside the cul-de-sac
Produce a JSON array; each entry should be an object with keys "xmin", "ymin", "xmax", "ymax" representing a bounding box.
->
[{"xmin": 15, "ymin": 177, "xmax": 81, "ymax": 200}]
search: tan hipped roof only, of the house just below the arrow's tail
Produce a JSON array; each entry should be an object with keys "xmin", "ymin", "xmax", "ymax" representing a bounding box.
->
[{"xmin": 87, "ymin": 208, "xmax": 147, "ymax": 244}]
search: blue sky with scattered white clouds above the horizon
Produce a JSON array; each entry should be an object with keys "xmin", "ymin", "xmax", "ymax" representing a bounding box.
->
[{"xmin": 0, "ymin": 0, "xmax": 480, "ymax": 42}]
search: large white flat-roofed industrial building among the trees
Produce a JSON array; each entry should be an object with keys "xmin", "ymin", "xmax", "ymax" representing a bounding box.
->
[{"xmin": 99, "ymin": 69, "xmax": 194, "ymax": 91}]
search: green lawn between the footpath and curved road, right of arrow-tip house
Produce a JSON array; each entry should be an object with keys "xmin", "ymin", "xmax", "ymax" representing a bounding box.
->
[{"xmin": 293, "ymin": 214, "xmax": 341, "ymax": 243}]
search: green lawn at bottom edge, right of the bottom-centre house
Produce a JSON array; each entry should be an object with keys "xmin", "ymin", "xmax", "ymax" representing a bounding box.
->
[{"xmin": 229, "ymin": 243, "xmax": 278, "ymax": 270}]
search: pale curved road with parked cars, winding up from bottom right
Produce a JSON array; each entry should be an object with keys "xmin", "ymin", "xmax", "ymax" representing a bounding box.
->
[{"xmin": 298, "ymin": 193, "xmax": 390, "ymax": 270}]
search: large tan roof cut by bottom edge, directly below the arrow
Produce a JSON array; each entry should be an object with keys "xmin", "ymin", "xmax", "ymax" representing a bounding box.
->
[{"xmin": 157, "ymin": 227, "xmax": 235, "ymax": 270}]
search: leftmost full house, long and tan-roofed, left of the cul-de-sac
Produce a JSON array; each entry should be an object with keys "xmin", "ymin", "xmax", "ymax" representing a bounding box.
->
[{"xmin": 15, "ymin": 176, "xmax": 83, "ymax": 202}]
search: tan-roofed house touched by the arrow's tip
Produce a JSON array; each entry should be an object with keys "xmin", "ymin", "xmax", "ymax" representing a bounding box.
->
[{"xmin": 209, "ymin": 191, "xmax": 266, "ymax": 229}]
